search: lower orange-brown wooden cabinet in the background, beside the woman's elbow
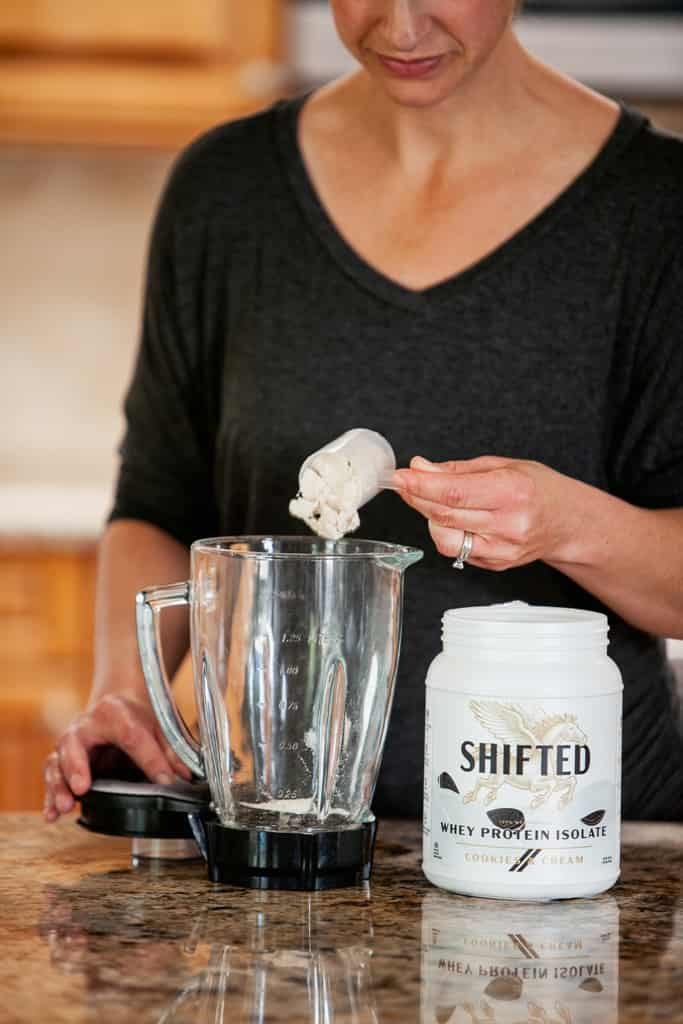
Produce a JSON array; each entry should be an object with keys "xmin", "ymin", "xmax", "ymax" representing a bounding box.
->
[{"xmin": 0, "ymin": 541, "xmax": 95, "ymax": 810}]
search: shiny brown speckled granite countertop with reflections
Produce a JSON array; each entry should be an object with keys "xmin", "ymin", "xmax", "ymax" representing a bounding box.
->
[{"xmin": 0, "ymin": 814, "xmax": 683, "ymax": 1024}]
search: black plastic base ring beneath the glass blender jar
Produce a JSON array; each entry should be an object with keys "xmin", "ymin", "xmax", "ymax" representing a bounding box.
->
[{"xmin": 204, "ymin": 818, "xmax": 377, "ymax": 892}]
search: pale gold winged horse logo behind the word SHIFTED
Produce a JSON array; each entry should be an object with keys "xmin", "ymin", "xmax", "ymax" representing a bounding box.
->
[{"xmin": 461, "ymin": 700, "xmax": 591, "ymax": 807}]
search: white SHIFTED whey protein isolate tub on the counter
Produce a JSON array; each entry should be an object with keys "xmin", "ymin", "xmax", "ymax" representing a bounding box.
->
[{"xmin": 423, "ymin": 601, "xmax": 623, "ymax": 900}]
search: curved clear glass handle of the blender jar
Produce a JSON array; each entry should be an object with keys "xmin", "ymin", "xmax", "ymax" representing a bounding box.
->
[{"xmin": 135, "ymin": 582, "xmax": 206, "ymax": 778}]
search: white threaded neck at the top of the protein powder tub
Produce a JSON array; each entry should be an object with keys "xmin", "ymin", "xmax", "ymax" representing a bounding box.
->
[{"xmin": 443, "ymin": 601, "xmax": 608, "ymax": 640}]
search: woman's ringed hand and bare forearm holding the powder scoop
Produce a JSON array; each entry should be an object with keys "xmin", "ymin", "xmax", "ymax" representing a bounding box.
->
[{"xmin": 393, "ymin": 456, "xmax": 683, "ymax": 637}]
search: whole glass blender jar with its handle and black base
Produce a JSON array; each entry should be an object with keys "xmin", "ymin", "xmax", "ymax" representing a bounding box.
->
[{"xmin": 137, "ymin": 537, "xmax": 422, "ymax": 889}]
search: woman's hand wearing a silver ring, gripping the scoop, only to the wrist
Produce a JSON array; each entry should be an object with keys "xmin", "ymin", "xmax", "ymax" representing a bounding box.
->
[{"xmin": 393, "ymin": 456, "xmax": 581, "ymax": 570}]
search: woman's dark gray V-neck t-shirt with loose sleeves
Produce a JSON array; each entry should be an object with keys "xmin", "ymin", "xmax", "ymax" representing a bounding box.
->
[{"xmin": 113, "ymin": 92, "xmax": 683, "ymax": 819}]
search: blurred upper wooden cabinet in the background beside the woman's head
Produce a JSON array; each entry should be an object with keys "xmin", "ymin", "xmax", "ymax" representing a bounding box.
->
[{"xmin": 0, "ymin": 0, "xmax": 284, "ymax": 147}]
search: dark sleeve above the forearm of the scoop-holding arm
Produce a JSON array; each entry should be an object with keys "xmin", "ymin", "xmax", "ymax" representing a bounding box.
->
[{"xmin": 612, "ymin": 244, "xmax": 683, "ymax": 508}]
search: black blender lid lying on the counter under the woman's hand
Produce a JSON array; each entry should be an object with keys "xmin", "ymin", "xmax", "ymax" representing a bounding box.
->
[{"xmin": 78, "ymin": 778, "xmax": 210, "ymax": 839}]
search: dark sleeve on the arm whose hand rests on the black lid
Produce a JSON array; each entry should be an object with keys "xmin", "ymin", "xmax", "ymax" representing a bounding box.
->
[{"xmin": 110, "ymin": 152, "xmax": 219, "ymax": 545}]
